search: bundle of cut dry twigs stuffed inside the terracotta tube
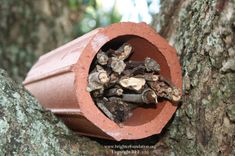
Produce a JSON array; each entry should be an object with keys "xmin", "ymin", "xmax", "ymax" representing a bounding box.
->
[{"xmin": 87, "ymin": 43, "xmax": 181, "ymax": 123}]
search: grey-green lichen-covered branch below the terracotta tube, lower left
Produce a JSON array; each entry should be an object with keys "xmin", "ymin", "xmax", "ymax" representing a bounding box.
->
[{"xmin": 0, "ymin": 69, "xmax": 110, "ymax": 156}]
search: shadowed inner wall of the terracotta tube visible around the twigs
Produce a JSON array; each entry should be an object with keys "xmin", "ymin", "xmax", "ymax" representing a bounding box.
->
[{"xmin": 90, "ymin": 35, "xmax": 171, "ymax": 126}]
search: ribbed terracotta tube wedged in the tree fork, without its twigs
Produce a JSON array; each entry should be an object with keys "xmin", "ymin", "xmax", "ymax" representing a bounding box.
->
[{"xmin": 24, "ymin": 22, "xmax": 182, "ymax": 140}]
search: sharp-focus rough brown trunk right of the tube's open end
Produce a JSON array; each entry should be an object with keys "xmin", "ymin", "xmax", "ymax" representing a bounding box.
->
[{"xmin": 153, "ymin": 0, "xmax": 235, "ymax": 155}]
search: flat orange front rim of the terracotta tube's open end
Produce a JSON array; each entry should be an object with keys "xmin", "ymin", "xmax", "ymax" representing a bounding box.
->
[{"xmin": 73, "ymin": 22, "xmax": 182, "ymax": 140}]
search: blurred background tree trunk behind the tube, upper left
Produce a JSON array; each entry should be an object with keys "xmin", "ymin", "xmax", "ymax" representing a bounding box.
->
[{"xmin": 0, "ymin": 0, "xmax": 83, "ymax": 82}]
